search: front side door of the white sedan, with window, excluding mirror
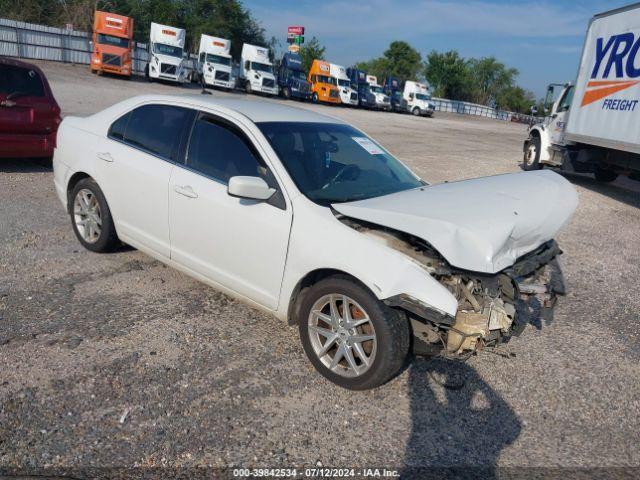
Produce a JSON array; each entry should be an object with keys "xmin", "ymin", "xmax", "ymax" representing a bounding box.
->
[{"xmin": 169, "ymin": 114, "xmax": 292, "ymax": 309}]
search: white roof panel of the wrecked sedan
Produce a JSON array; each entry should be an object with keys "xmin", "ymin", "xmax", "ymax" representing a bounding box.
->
[{"xmin": 129, "ymin": 94, "xmax": 345, "ymax": 124}]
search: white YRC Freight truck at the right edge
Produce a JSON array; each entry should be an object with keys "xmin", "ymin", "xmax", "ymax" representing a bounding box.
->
[{"xmin": 523, "ymin": 3, "xmax": 640, "ymax": 182}]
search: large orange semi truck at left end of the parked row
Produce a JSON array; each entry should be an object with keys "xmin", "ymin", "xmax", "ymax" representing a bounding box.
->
[{"xmin": 91, "ymin": 10, "xmax": 133, "ymax": 77}]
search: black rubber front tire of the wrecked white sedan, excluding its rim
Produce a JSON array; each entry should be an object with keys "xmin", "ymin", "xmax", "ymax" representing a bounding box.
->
[{"xmin": 297, "ymin": 276, "xmax": 411, "ymax": 390}]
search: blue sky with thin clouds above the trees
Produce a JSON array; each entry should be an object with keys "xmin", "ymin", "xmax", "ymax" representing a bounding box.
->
[{"xmin": 243, "ymin": 0, "xmax": 632, "ymax": 97}]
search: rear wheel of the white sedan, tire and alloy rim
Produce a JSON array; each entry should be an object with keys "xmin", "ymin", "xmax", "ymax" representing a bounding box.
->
[{"xmin": 69, "ymin": 178, "xmax": 119, "ymax": 253}]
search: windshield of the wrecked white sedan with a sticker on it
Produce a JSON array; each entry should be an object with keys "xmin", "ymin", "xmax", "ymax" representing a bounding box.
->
[{"xmin": 258, "ymin": 122, "xmax": 424, "ymax": 205}]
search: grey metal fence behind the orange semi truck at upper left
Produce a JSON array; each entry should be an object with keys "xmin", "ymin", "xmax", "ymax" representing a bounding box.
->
[{"xmin": 0, "ymin": 18, "xmax": 195, "ymax": 75}]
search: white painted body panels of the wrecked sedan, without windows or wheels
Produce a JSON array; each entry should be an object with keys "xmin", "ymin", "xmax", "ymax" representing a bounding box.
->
[{"xmin": 53, "ymin": 95, "xmax": 577, "ymax": 386}]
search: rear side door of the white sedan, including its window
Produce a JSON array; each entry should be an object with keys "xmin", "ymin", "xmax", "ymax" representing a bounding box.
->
[{"xmin": 97, "ymin": 104, "xmax": 195, "ymax": 258}]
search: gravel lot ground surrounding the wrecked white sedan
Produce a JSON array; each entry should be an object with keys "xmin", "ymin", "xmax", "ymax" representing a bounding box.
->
[{"xmin": 0, "ymin": 63, "xmax": 640, "ymax": 475}]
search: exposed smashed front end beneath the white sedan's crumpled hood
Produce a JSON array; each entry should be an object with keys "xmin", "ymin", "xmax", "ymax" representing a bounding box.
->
[{"xmin": 338, "ymin": 216, "xmax": 564, "ymax": 357}]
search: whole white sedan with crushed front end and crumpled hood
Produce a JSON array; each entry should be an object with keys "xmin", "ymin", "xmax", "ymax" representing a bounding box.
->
[{"xmin": 53, "ymin": 96, "xmax": 577, "ymax": 389}]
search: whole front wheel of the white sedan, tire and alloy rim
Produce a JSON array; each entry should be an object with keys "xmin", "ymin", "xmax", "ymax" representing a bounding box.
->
[{"xmin": 298, "ymin": 276, "xmax": 410, "ymax": 390}]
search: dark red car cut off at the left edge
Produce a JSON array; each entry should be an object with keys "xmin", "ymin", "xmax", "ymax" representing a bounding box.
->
[{"xmin": 0, "ymin": 57, "xmax": 61, "ymax": 158}]
